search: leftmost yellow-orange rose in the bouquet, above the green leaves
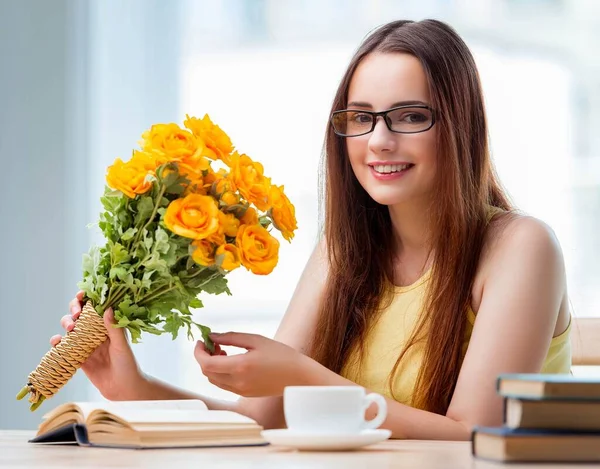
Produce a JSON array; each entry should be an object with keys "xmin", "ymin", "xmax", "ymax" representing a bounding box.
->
[{"xmin": 106, "ymin": 152, "xmax": 157, "ymax": 198}]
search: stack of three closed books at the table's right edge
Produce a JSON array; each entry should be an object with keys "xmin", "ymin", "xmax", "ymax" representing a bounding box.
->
[{"xmin": 471, "ymin": 374, "xmax": 600, "ymax": 462}]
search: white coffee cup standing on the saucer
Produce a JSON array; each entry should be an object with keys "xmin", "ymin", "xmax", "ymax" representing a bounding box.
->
[{"xmin": 283, "ymin": 386, "xmax": 387, "ymax": 433}]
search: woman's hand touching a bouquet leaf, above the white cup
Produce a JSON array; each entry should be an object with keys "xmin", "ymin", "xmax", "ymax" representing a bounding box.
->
[{"xmin": 194, "ymin": 332, "xmax": 316, "ymax": 397}]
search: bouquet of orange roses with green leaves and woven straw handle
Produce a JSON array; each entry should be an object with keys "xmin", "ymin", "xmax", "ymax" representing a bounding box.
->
[{"xmin": 17, "ymin": 116, "xmax": 297, "ymax": 410}]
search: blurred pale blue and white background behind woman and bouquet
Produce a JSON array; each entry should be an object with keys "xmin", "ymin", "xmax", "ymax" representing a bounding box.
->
[{"xmin": 0, "ymin": 0, "xmax": 600, "ymax": 428}]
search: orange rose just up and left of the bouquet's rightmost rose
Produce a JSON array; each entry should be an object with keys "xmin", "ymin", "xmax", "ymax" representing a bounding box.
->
[{"xmin": 230, "ymin": 152, "xmax": 271, "ymax": 210}]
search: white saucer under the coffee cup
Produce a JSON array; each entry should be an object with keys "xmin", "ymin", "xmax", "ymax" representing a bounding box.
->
[{"xmin": 261, "ymin": 428, "xmax": 392, "ymax": 451}]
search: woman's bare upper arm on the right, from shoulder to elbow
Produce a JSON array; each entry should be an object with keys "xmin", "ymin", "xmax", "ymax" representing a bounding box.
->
[{"xmin": 447, "ymin": 217, "xmax": 569, "ymax": 432}]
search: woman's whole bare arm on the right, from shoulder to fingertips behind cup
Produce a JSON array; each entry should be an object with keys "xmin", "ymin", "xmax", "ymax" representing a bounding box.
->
[{"xmin": 197, "ymin": 218, "xmax": 566, "ymax": 440}]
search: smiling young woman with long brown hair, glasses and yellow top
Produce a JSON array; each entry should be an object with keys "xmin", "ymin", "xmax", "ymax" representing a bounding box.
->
[{"xmin": 52, "ymin": 20, "xmax": 571, "ymax": 440}]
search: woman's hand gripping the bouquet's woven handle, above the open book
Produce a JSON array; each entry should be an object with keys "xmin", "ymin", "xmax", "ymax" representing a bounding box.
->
[{"xmin": 50, "ymin": 291, "xmax": 146, "ymax": 401}]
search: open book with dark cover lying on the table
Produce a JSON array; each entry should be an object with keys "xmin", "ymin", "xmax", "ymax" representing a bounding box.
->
[{"xmin": 30, "ymin": 399, "xmax": 267, "ymax": 448}]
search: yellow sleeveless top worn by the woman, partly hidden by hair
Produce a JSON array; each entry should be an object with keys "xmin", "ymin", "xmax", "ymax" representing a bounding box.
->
[{"xmin": 341, "ymin": 208, "xmax": 572, "ymax": 405}]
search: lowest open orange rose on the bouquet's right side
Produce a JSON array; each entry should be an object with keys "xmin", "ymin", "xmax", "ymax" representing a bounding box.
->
[{"xmin": 235, "ymin": 225, "xmax": 279, "ymax": 275}]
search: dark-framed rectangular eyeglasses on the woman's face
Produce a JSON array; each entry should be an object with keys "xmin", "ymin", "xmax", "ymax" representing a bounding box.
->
[{"xmin": 330, "ymin": 104, "xmax": 435, "ymax": 137}]
